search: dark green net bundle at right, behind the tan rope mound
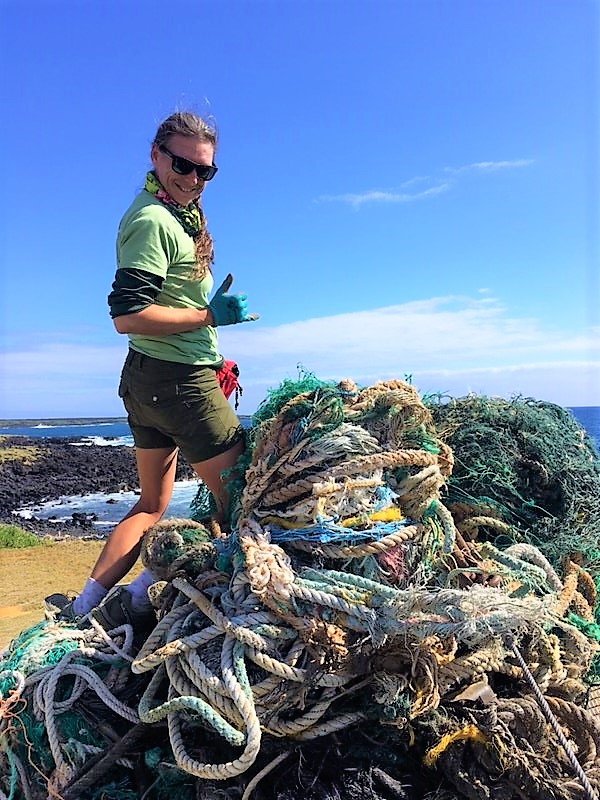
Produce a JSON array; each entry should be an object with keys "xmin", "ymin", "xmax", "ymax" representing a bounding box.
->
[{"xmin": 427, "ymin": 396, "xmax": 600, "ymax": 572}]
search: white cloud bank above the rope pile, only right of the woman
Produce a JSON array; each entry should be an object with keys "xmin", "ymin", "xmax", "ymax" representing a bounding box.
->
[{"xmin": 221, "ymin": 295, "xmax": 600, "ymax": 405}]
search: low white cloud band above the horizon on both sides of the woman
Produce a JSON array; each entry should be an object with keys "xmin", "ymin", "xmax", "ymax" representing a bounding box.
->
[{"xmin": 0, "ymin": 292, "xmax": 600, "ymax": 418}]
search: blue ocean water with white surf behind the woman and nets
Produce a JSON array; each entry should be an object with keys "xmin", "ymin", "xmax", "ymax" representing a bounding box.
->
[{"xmin": 0, "ymin": 406, "xmax": 600, "ymax": 534}]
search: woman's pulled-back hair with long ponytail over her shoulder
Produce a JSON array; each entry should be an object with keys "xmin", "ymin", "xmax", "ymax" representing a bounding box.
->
[{"xmin": 153, "ymin": 111, "xmax": 217, "ymax": 280}]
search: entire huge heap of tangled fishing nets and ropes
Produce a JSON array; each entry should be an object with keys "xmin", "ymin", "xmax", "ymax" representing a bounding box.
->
[{"xmin": 0, "ymin": 375, "xmax": 600, "ymax": 800}]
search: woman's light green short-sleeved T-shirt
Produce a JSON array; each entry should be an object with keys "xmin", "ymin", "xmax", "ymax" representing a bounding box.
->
[{"xmin": 113, "ymin": 190, "xmax": 222, "ymax": 366}]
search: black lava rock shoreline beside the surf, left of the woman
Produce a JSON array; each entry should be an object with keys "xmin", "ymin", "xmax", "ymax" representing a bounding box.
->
[{"xmin": 0, "ymin": 436, "xmax": 193, "ymax": 537}]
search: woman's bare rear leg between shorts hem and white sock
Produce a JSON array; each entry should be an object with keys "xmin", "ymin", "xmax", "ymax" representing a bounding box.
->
[{"xmin": 91, "ymin": 447, "xmax": 178, "ymax": 589}]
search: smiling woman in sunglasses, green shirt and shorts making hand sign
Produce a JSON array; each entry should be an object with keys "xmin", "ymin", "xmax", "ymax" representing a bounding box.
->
[{"xmin": 48, "ymin": 112, "xmax": 257, "ymax": 627}]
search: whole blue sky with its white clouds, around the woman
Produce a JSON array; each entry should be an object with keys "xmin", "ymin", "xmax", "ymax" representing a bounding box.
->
[{"xmin": 0, "ymin": 0, "xmax": 600, "ymax": 418}]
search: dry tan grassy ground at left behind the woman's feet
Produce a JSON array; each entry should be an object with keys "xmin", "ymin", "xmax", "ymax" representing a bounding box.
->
[{"xmin": 0, "ymin": 540, "xmax": 142, "ymax": 650}]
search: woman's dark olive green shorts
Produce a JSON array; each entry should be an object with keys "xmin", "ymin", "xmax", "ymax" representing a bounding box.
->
[{"xmin": 119, "ymin": 350, "xmax": 244, "ymax": 464}]
